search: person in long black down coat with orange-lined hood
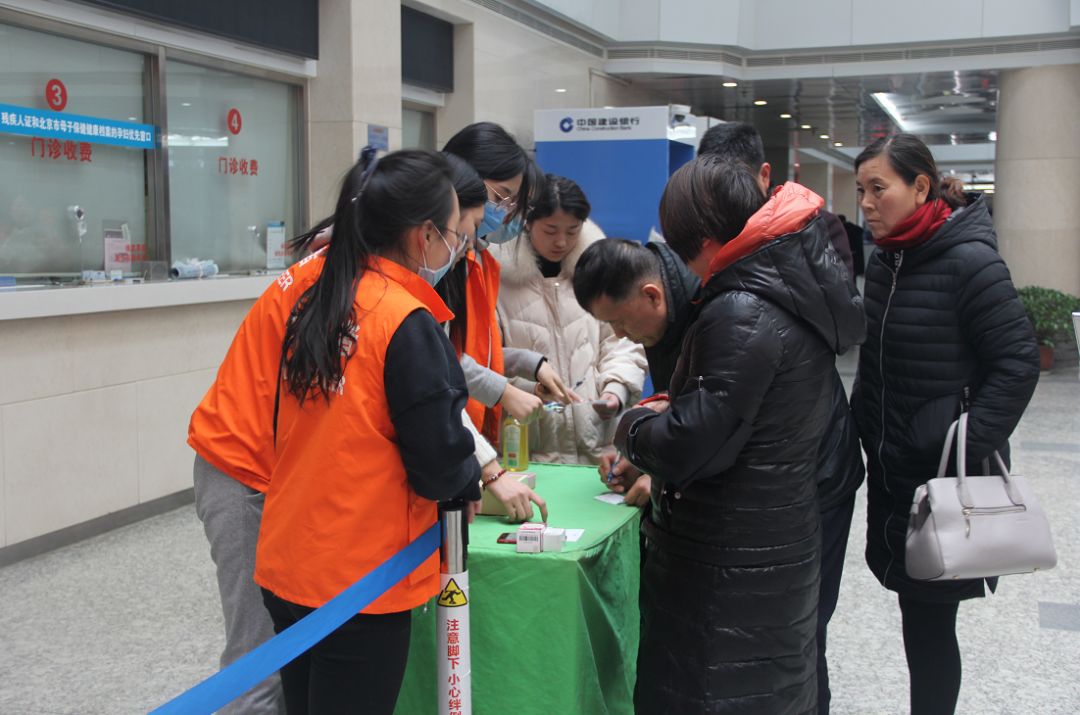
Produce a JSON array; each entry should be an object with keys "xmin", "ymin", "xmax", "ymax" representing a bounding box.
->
[{"xmin": 616, "ymin": 157, "xmax": 864, "ymax": 715}]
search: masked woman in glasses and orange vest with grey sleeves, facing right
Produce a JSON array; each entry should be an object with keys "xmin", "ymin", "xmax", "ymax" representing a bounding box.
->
[{"xmin": 443, "ymin": 122, "xmax": 575, "ymax": 451}]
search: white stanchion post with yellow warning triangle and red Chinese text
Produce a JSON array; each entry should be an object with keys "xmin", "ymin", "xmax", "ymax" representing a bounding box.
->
[{"xmin": 435, "ymin": 501, "xmax": 472, "ymax": 715}]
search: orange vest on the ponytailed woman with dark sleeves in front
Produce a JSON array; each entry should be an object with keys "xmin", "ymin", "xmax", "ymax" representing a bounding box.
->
[{"xmin": 255, "ymin": 258, "xmax": 460, "ymax": 613}]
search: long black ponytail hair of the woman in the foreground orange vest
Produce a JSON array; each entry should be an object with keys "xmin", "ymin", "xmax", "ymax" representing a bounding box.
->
[{"xmin": 282, "ymin": 148, "xmax": 455, "ymax": 404}]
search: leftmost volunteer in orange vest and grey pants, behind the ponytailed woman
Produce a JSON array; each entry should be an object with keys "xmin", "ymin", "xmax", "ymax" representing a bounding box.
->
[{"xmin": 188, "ymin": 147, "xmax": 548, "ymax": 715}]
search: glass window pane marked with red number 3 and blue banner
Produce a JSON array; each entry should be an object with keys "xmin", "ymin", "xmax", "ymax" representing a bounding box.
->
[{"xmin": 0, "ymin": 25, "xmax": 147, "ymax": 284}]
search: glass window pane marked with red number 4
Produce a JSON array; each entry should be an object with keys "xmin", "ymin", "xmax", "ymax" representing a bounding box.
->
[{"xmin": 165, "ymin": 60, "xmax": 300, "ymax": 273}]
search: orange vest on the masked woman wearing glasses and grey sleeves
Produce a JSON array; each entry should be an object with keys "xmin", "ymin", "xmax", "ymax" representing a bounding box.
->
[{"xmin": 462, "ymin": 251, "xmax": 504, "ymax": 446}]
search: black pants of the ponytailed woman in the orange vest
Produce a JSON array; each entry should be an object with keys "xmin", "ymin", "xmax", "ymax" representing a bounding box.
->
[{"xmin": 262, "ymin": 589, "xmax": 413, "ymax": 715}]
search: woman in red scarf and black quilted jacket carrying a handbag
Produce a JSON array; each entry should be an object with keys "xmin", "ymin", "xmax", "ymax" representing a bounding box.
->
[{"xmin": 852, "ymin": 134, "xmax": 1039, "ymax": 715}]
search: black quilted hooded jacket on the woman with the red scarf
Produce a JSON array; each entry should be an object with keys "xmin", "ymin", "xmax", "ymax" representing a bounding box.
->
[{"xmin": 852, "ymin": 199, "xmax": 1039, "ymax": 602}]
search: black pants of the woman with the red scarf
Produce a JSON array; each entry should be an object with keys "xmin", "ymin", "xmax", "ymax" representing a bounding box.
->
[{"xmin": 900, "ymin": 596, "xmax": 961, "ymax": 715}]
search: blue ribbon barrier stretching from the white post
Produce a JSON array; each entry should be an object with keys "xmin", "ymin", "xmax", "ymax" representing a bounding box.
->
[{"xmin": 150, "ymin": 522, "xmax": 442, "ymax": 715}]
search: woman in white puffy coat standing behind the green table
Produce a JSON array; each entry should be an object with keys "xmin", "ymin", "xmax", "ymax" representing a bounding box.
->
[{"xmin": 490, "ymin": 174, "xmax": 647, "ymax": 464}]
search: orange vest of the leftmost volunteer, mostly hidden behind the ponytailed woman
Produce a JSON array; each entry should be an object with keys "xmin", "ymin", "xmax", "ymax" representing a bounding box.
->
[{"xmin": 188, "ymin": 251, "xmax": 325, "ymax": 491}]
